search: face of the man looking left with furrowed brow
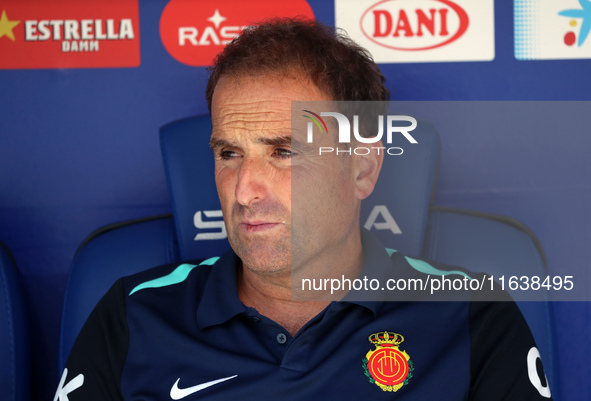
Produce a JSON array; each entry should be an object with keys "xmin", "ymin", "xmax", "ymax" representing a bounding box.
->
[{"xmin": 211, "ymin": 75, "xmax": 366, "ymax": 274}]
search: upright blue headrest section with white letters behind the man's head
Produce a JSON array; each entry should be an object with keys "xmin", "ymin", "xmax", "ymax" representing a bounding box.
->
[{"xmin": 160, "ymin": 116, "xmax": 439, "ymax": 259}]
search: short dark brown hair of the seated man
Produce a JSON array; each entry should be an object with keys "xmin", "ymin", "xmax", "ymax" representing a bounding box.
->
[{"xmin": 206, "ymin": 18, "xmax": 390, "ymax": 111}]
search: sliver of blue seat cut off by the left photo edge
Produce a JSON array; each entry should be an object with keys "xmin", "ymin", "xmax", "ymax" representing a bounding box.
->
[{"xmin": 0, "ymin": 242, "xmax": 31, "ymax": 401}]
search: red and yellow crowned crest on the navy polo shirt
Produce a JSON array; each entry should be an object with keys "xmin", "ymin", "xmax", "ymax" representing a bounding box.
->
[{"xmin": 363, "ymin": 331, "xmax": 414, "ymax": 391}]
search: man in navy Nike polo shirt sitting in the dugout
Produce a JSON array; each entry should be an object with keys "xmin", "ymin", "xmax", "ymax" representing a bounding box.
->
[{"xmin": 56, "ymin": 20, "xmax": 550, "ymax": 401}]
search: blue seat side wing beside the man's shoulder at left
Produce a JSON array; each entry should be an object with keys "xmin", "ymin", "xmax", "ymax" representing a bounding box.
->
[{"xmin": 59, "ymin": 215, "xmax": 179, "ymax": 371}]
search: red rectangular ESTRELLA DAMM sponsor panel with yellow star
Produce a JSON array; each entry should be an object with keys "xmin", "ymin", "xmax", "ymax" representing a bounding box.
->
[{"xmin": 0, "ymin": 0, "xmax": 140, "ymax": 69}]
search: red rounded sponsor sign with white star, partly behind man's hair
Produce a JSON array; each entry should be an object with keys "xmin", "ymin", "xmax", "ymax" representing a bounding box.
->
[{"xmin": 160, "ymin": 0, "xmax": 314, "ymax": 67}]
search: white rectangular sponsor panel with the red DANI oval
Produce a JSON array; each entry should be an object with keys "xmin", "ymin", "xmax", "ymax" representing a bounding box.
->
[{"xmin": 335, "ymin": 0, "xmax": 494, "ymax": 63}]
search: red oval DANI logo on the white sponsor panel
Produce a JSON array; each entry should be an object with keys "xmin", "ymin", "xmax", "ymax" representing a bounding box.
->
[{"xmin": 360, "ymin": 0, "xmax": 470, "ymax": 51}]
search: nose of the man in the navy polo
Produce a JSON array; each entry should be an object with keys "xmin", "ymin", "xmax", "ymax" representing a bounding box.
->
[{"xmin": 236, "ymin": 158, "xmax": 269, "ymax": 206}]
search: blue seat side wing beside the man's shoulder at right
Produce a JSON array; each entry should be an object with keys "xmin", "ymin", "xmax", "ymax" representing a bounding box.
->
[{"xmin": 423, "ymin": 207, "xmax": 560, "ymax": 400}]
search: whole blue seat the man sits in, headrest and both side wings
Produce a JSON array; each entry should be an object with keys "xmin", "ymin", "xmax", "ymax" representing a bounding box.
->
[{"xmin": 60, "ymin": 116, "xmax": 556, "ymax": 394}]
